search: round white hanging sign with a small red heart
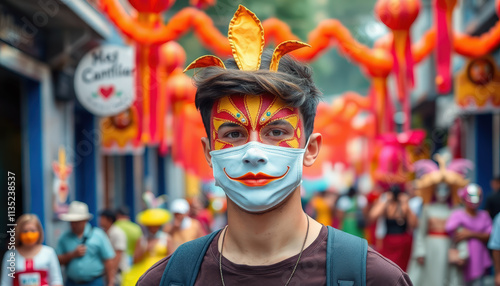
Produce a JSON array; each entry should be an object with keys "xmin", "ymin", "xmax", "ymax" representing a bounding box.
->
[{"xmin": 75, "ymin": 45, "xmax": 135, "ymax": 116}]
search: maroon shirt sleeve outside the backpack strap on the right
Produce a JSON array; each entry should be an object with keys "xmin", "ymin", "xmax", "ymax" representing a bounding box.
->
[{"xmin": 366, "ymin": 247, "xmax": 412, "ymax": 286}]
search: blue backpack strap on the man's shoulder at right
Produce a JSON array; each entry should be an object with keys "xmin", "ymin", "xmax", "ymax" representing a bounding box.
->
[{"xmin": 326, "ymin": 226, "xmax": 368, "ymax": 286}]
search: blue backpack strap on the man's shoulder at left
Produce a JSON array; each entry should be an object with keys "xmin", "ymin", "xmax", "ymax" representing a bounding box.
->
[{"xmin": 160, "ymin": 230, "xmax": 220, "ymax": 286}]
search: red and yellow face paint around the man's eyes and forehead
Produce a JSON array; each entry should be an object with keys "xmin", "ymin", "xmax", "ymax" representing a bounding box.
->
[{"xmin": 210, "ymin": 95, "xmax": 304, "ymax": 150}]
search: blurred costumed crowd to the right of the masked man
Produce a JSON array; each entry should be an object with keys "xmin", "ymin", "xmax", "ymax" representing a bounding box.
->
[{"xmin": 305, "ymin": 176, "xmax": 500, "ymax": 286}]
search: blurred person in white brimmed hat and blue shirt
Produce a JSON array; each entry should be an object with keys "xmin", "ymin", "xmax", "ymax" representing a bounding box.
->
[{"xmin": 56, "ymin": 201, "xmax": 115, "ymax": 286}]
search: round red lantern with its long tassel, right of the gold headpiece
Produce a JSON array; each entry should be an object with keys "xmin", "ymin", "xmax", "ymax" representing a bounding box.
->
[{"xmin": 375, "ymin": 0, "xmax": 421, "ymax": 130}]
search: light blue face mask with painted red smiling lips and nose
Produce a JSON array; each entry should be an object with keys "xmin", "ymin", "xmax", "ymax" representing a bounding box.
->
[{"xmin": 210, "ymin": 141, "xmax": 309, "ymax": 212}]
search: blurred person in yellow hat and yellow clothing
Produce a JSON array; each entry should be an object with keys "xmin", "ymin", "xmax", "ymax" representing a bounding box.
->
[{"xmin": 122, "ymin": 208, "xmax": 172, "ymax": 286}]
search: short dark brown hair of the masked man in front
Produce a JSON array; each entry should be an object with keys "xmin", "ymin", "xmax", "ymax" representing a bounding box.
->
[{"xmin": 194, "ymin": 50, "xmax": 321, "ymax": 142}]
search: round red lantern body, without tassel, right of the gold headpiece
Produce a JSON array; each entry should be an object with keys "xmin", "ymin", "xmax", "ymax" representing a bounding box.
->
[{"xmin": 375, "ymin": 0, "xmax": 420, "ymax": 30}]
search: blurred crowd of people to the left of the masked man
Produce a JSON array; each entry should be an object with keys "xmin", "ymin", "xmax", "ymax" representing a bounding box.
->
[{"xmin": 1, "ymin": 194, "xmax": 224, "ymax": 286}]
